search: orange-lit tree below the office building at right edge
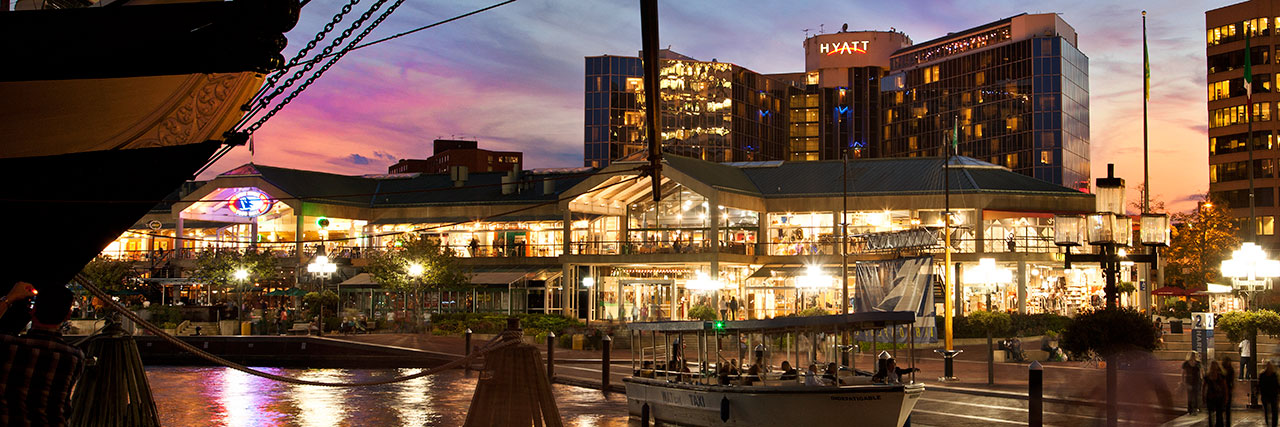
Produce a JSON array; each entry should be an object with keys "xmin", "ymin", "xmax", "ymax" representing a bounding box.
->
[{"xmin": 1161, "ymin": 194, "xmax": 1240, "ymax": 289}]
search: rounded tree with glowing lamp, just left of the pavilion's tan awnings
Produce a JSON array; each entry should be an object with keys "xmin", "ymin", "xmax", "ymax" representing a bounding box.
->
[{"xmin": 365, "ymin": 235, "xmax": 471, "ymax": 329}]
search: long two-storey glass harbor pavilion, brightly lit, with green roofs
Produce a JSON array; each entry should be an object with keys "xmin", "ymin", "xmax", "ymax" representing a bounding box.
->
[{"xmin": 104, "ymin": 155, "xmax": 1116, "ymax": 322}]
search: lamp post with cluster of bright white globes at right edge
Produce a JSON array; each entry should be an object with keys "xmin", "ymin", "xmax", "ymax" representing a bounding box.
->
[{"xmin": 1221, "ymin": 242, "xmax": 1280, "ymax": 407}]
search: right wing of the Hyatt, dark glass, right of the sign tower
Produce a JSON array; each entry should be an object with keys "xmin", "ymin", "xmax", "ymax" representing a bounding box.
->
[{"xmin": 873, "ymin": 14, "xmax": 1089, "ymax": 189}]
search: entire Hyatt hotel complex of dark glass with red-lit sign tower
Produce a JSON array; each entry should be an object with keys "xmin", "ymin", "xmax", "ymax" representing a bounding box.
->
[{"xmin": 584, "ymin": 14, "xmax": 1089, "ymax": 190}]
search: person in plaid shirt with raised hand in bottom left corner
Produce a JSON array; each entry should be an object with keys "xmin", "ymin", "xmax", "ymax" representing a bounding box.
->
[{"xmin": 0, "ymin": 281, "xmax": 84, "ymax": 426}]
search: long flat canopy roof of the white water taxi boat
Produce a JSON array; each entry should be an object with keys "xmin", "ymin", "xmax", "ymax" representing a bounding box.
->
[{"xmin": 627, "ymin": 311, "xmax": 915, "ymax": 332}]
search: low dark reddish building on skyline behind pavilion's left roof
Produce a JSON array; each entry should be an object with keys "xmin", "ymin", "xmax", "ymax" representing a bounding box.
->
[{"xmin": 387, "ymin": 139, "xmax": 525, "ymax": 174}]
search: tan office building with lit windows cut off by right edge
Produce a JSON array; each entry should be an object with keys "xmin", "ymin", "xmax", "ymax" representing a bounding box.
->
[{"xmin": 1204, "ymin": 0, "xmax": 1280, "ymax": 245}]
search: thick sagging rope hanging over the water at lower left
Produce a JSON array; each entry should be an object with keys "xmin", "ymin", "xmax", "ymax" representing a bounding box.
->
[{"xmin": 74, "ymin": 274, "xmax": 521, "ymax": 387}]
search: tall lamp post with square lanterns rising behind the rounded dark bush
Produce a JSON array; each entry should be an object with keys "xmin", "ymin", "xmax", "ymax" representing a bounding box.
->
[{"xmin": 1053, "ymin": 164, "xmax": 1169, "ymax": 426}]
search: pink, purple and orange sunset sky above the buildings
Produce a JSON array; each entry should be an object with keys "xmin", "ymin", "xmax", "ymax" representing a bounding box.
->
[{"xmin": 201, "ymin": 0, "xmax": 1218, "ymax": 211}]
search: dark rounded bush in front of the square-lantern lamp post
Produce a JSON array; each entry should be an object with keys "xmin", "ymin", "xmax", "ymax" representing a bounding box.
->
[{"xmin": 1061, "ymin": 307, "xmax": 1158, "ymax": 358}]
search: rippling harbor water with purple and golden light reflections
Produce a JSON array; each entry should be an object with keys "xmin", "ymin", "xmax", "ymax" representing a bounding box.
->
[{"xmin": 147, "ymin": 367, "xmax": 627, "ymax": 427}]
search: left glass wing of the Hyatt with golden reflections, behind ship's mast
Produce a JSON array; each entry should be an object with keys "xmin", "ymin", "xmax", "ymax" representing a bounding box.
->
[{"xmin": 582, "ymin": 50, "xmax": 794, "ymax": 167}]
